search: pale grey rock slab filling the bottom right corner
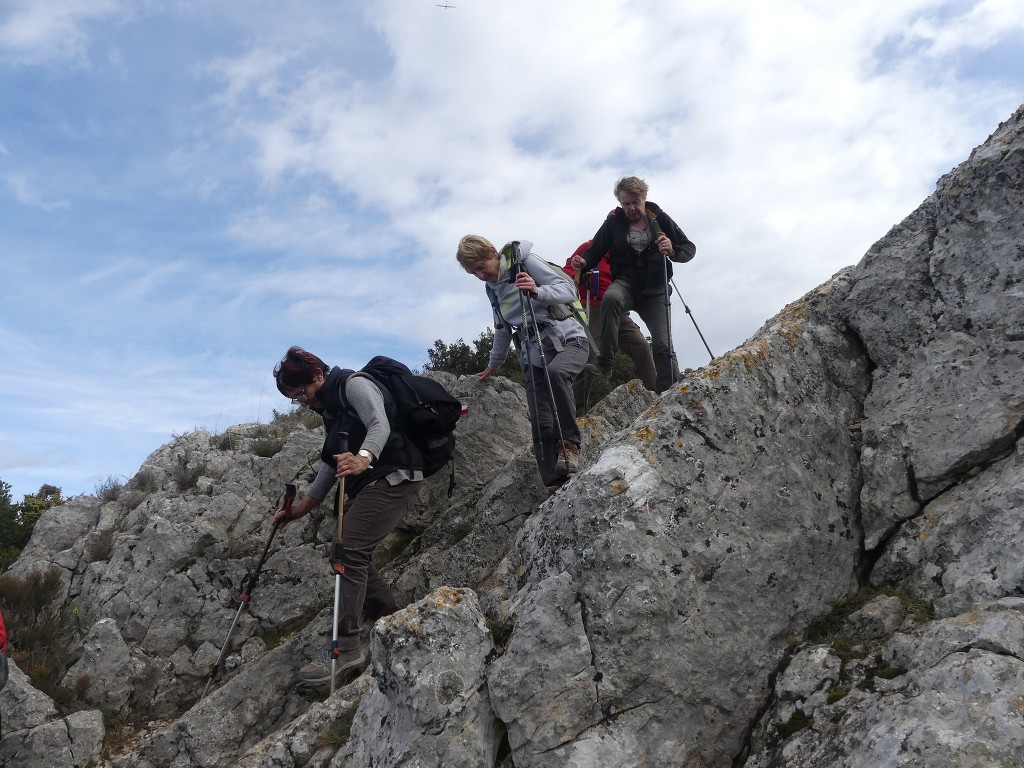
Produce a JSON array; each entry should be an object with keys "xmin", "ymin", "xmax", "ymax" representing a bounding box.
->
[{"xmin": 746, "ymin": 606, "xmax": 1024, "ymax": 768}]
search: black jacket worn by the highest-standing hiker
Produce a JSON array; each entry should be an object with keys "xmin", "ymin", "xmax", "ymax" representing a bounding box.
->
[{"xmin": 583, "ymin": 201, "xmax": 697, "ymax": 294}]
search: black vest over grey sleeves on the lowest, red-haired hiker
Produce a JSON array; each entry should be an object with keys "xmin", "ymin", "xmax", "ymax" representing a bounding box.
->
[{"xmin": 314, "ymin": 366, "xmax": 424, "ymax": 497}]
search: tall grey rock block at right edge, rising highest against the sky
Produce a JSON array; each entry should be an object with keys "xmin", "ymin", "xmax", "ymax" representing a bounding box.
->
[{"xmin": 844, "ymin": 110, "xmax": 1024, "ymax": 549}]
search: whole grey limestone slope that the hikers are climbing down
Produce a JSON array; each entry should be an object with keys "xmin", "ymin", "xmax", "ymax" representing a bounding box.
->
[{"xmin": 0, "ymin": 103, "xmax": 1024, "ymax": 768}]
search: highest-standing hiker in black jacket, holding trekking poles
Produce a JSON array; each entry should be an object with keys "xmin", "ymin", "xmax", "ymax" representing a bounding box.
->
[{"xmin": 572, "ymin": 176, "xmax": 696, "ymax": 392}]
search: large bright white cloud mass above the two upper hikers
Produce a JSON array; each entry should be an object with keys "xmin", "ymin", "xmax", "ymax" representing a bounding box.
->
[{"xmin": 203, "ymin": 0, "xmax": 1019, "ymax": 330}]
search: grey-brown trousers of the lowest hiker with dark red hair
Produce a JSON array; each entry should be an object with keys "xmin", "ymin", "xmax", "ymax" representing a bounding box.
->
[{"xmin": 338, "ymin": 479, "xmax": 421, "ymax": 651}]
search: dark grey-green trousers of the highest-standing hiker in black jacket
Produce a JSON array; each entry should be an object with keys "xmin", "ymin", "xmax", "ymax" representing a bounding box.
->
[{"xmin": 598, "ymin": 278, "xmax": 679, "ymax": 392}]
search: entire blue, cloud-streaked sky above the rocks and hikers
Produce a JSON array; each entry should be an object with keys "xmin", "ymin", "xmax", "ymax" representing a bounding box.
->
[{"xmin": 0, "ymin": 0, "xmax": 1024, "ymax": 501}]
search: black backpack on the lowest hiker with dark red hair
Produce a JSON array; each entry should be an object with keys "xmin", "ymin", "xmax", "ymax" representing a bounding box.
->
[{"xmin": 359, "ymin": 354, "xmax": 466, "ymax": 496}]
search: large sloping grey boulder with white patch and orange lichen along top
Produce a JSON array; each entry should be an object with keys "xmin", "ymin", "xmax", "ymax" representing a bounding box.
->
[{"xmin": 487, "ymin": 278, "xmax": 866, "ymax": 765}]
